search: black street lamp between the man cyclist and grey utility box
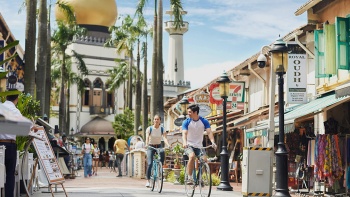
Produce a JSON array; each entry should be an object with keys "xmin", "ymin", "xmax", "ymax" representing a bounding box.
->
[{"xmin": 216, "ymin": 71, "xmax": 233, "ymax": 191}]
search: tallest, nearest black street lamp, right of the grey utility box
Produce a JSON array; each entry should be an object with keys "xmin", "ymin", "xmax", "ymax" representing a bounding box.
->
[{"xmin": 270, "ymin": 39, "xmax": 290, "ymax": 196}]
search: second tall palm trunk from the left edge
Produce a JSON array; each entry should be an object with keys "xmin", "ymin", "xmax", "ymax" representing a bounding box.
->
[{"xmin": 35, "ymin": 0, "xmax": 50, "ymax": 117}]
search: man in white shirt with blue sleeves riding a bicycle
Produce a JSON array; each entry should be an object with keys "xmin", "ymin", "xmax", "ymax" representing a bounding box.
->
[{"xmin": 182, "ymin": 105, "xmax": 216, "ymax": 184}]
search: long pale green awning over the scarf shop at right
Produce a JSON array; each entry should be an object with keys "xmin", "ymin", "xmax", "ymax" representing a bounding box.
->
[{"xmin": 246, "ymin": 93, "xmax": 350, "ymax": 133}]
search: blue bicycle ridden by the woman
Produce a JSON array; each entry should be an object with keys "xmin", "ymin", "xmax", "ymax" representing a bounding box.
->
[{"xmin": 148, "ymin": 146, "xmax": 167, "ymax": 193}]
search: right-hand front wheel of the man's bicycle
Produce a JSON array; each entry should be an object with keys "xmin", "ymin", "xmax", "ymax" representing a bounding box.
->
[{"xmin": 198, "ymin": 163, "xmax": 212, "ymax": 197}]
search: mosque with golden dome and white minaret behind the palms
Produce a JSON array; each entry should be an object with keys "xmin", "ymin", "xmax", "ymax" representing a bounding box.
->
[{"xmin": 50, "ymin": 0, "xmax": 190, "ymax": 150}]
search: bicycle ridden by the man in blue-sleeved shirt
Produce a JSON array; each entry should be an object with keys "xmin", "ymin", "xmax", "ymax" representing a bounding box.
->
[{"xmin": 185, "ymin": 145, "xmax": 213, "ymax": 197}]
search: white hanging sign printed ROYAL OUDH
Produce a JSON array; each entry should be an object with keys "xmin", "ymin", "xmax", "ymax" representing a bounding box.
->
[{"xmin": 287, "ymin": 54, "xmax": 307, "ymax": 104}]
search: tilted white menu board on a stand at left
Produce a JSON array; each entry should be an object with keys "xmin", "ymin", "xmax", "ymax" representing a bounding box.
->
[{"xmin": 31, "ymin": 130, "xmax": 65, "ymax": 184}]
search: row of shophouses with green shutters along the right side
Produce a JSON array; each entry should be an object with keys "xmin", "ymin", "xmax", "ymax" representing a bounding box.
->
[{"xmin": 165, "ymin": 0, "xmax": 350, "ymax": 189}]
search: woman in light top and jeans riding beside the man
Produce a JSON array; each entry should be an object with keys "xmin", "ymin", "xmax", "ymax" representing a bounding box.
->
[{"xmin": 145, "ymin": 115, "xmax": 170, "ymax": 187}]
